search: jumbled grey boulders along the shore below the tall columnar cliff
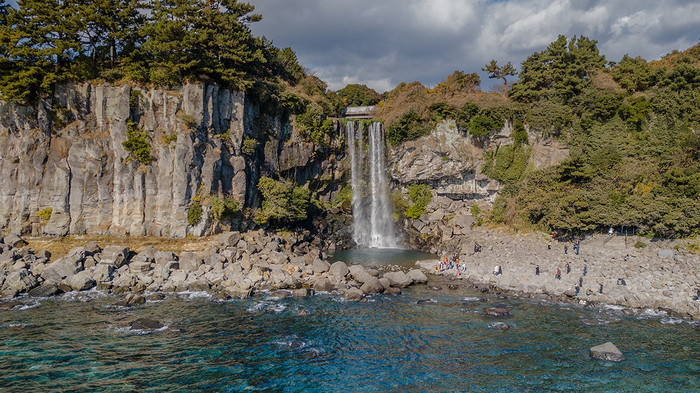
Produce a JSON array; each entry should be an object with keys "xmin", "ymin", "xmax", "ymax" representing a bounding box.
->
[{"xmin": 0, "ymin": 230, "xmax": 428, "ymax": 306}]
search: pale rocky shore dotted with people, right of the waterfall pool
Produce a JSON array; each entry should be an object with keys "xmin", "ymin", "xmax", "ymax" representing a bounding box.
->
[{"xmin": 417, "ymin": 228, "xmax": 700, "ymax": 320}]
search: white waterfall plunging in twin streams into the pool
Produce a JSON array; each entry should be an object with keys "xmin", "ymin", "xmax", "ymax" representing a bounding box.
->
[{"xmin": 346, "ymin": 121, "xmax": 398, "ymax": 248}]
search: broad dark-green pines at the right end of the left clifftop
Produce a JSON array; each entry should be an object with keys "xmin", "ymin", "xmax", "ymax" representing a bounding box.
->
[{"xmin": 130, "ymin": 0, "xmax": 266, "ymax": 88}]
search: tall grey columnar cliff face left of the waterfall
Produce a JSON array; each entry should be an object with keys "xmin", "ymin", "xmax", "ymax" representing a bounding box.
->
[{"xmin": 0, "ymin": 84, "xmax": 344, "ymax": 237}]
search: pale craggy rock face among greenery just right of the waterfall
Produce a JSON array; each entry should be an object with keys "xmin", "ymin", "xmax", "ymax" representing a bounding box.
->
[{"xmin": 388, "ymin": 120, "xmax": 569, "ymax": 252}]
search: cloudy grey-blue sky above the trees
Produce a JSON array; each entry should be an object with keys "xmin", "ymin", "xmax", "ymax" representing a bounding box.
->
[{"xmin": 247, "ymin": 0, "xmax": 700, "ymax": 92}]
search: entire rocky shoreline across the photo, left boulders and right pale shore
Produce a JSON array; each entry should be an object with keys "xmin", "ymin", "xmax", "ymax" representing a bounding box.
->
[{"xmin": 0, "ymin": 228, "xmax": 700, "ymax": 320}]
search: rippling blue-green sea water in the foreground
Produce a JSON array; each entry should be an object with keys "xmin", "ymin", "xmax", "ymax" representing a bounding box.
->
[{"xmin": 0, "ymin": 250, "xmax": 700, "ymax": 392}]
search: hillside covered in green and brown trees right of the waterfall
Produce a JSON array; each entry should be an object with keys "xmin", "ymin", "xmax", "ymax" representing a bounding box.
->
[{"xmin": 379, "ymin": 36, "xmax": 700, "ymax": 237}]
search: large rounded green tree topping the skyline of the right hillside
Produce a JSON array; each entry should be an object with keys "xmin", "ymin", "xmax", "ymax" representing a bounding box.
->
[{"xmin": 510, "ymin": 35, "xmax": 605, "ymax": 102}]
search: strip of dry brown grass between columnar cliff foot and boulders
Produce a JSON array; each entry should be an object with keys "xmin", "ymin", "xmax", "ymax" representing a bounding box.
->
[{"xmin": 24, "ymin": 235, "xmax": 217, "ymax": 261}]
